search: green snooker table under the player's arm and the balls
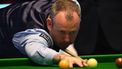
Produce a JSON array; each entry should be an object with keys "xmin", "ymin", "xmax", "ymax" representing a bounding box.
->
[{"xmin": 0, "ymin": 54, "xmax": 122, "ymax": 69}]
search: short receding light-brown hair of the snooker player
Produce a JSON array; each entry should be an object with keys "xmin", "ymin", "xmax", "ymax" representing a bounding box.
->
[{"xmin": 50, "ymin": 0, "xmax": 81, "ymax": 19}]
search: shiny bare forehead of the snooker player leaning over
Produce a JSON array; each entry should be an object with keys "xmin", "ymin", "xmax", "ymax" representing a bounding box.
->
[{"xmin": 54, "ymin": 11, "xmax": 80, "ymax": 27}]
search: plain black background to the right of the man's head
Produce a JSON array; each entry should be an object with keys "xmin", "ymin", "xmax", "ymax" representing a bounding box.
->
[{"xmin": 75, "ymin": 0, "xmax": 122, "ymax": 55}]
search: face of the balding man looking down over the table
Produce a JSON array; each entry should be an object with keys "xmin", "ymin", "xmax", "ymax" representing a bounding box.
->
[{"xmin": 47, "ymin": 11, "xmax": 80, "ymax": 49}]
